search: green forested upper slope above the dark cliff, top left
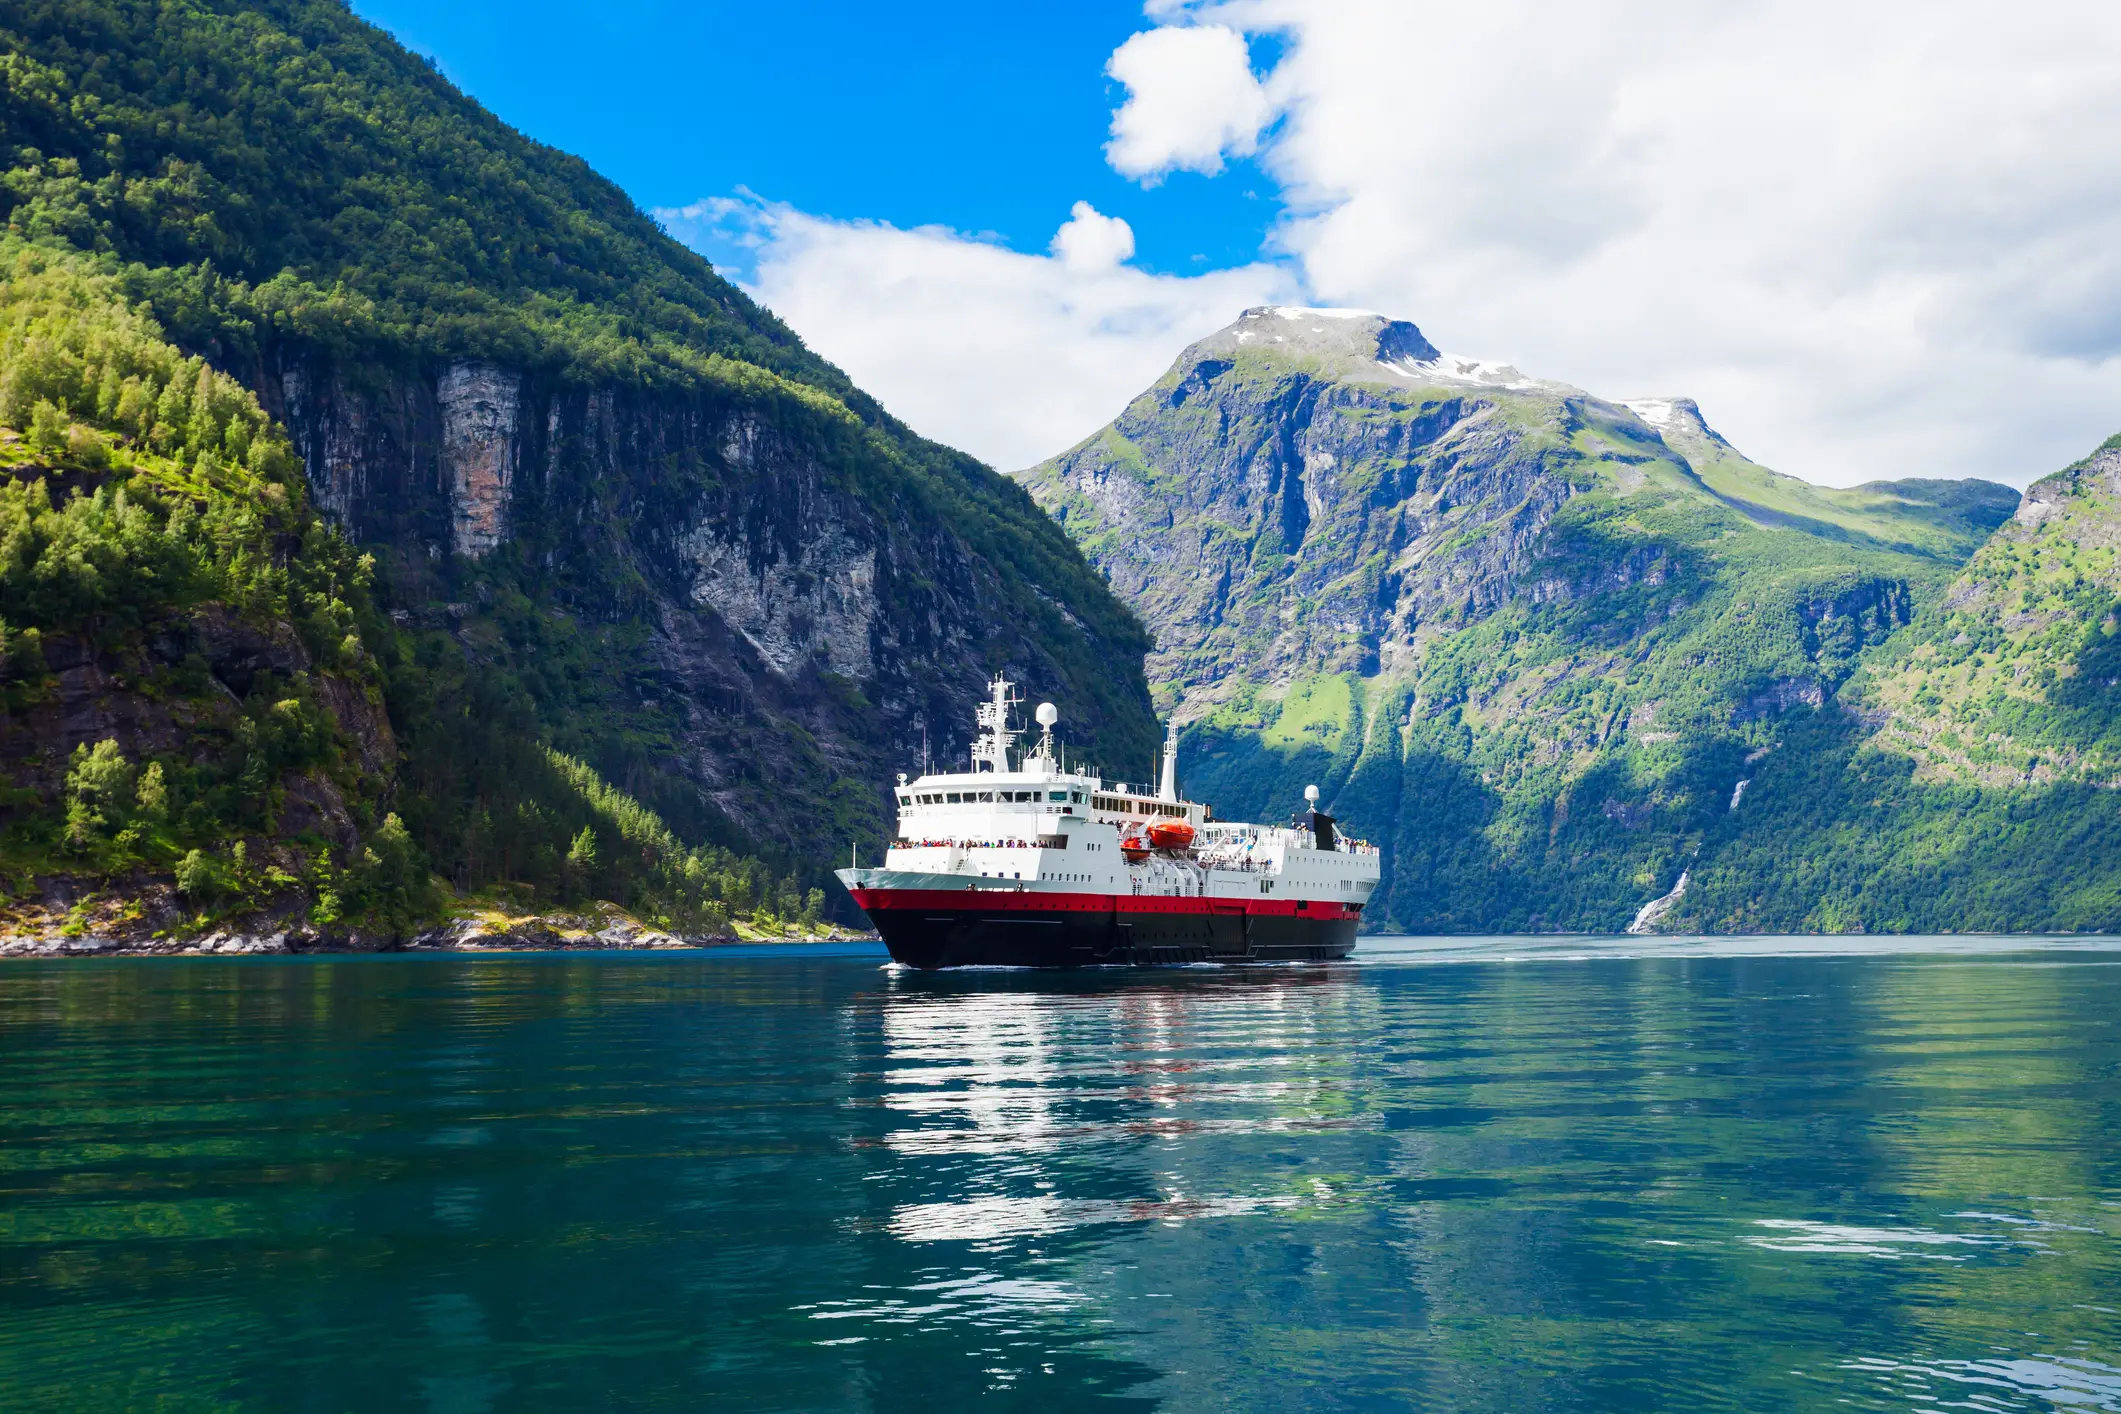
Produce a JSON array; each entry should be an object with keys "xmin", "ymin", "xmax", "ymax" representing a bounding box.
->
[{"xmin": 0, "ymin": 0, "xmax": 844, "ymax": 392}]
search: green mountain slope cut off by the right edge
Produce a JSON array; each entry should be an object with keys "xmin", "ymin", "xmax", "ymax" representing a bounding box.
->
[{"xmin": 1667, "ymin": 437, "xmax": 2121, "ymax": 933}]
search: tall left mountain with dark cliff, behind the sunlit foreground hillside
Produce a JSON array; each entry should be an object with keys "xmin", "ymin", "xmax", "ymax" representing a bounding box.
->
[{"xmin": 0, "ymin": 0, "xmax": 1156, "ymax": 945}]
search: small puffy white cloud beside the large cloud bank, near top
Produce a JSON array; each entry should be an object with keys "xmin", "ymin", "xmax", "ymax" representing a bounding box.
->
[{"xmin": 1105, "ymin": 25, "xmax": 1273, "ymax": 180}]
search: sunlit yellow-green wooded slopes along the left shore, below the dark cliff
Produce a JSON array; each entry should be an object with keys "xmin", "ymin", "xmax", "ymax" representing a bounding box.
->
[{"xmin": 0, "ymin": 237, "xmax": 817, "ymax": 935}]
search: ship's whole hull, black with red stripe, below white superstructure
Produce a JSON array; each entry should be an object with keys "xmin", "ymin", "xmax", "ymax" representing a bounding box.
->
[{"xmin": 853, "ymin": 888, "xmax": 1362, "ymax": 971}]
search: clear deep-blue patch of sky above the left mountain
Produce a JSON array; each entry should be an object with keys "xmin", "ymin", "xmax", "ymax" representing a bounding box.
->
[{"xmin": 354, "ymin": 0, "xmax": 1279, "ymax": 273}]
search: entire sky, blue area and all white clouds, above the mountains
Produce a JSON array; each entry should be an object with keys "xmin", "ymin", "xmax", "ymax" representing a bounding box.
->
[{"xmin": 354, "ymin": 0, "xmax": 2121, "ymax": 485}]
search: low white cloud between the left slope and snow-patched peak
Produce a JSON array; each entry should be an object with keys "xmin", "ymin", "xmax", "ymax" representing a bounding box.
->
[{"xmin": 655, "ymin": 199, "xmax": 1296, "ymax": 471}]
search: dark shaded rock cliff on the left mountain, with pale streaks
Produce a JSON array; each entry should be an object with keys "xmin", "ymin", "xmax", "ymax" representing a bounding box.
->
[{"xmin": 255, "ymin": 346, "xmax": 1154, "ymax": 861}]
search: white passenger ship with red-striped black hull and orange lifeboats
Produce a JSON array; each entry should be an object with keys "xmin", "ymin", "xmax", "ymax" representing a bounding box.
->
[{"xmin": 838, "ymin": 676, "xmax": 1379, "ymax": 971}]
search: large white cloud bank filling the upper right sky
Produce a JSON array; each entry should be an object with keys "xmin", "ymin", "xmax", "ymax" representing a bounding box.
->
[{"xmin": 1145, "ymin": 0, "xmax": 2121, "ymax": 483}]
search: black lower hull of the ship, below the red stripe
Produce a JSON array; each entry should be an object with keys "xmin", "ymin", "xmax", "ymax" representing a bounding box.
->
[{"xmin": 870, "ymin": 895, "xmax": 1360, "ymax": 971}]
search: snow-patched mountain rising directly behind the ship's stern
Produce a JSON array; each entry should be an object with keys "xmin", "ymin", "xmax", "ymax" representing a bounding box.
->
[{"xmin": 1020, "ymin": 307, "xmax": 2017, "ymax": 931}]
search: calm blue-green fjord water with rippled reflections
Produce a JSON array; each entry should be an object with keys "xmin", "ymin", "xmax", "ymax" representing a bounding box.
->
[{"xmin": 0, "ymin": 939, "xmax": 2121, "ymax": 1412}]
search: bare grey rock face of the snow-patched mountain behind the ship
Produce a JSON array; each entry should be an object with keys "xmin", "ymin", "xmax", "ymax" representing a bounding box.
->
[{"xmin": 1027, "ymin": 310, "xmax": 1603, "ymax": 714}]
